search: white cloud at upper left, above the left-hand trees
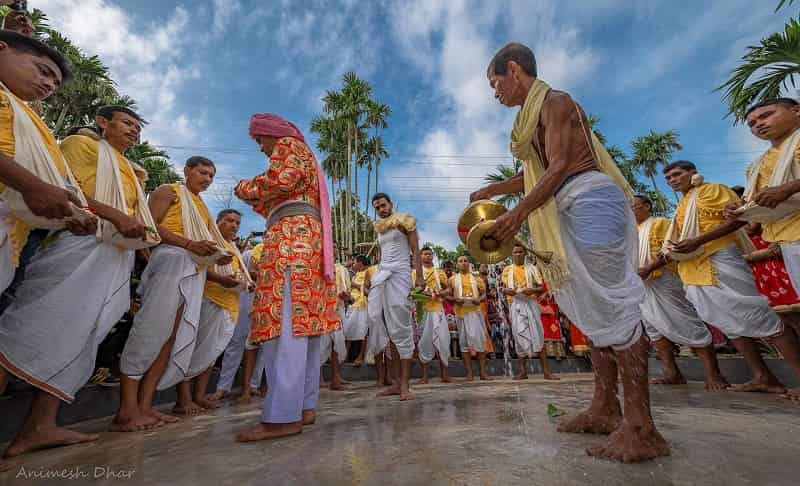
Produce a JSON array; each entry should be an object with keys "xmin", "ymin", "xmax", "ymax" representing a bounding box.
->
[{"xmin": 30, "ymin": 0, "xmax": 203, "ymax": 145}]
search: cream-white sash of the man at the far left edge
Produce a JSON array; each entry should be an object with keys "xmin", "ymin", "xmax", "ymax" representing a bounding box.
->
[{"xmin": 0, "ymin": 82, "xmax": 93, "ymax": 230}]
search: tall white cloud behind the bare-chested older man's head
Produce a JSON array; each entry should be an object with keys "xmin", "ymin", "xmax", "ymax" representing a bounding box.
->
[{"xmin": 385, "ymin": 0, "xmax": 598, "ymax": 247}]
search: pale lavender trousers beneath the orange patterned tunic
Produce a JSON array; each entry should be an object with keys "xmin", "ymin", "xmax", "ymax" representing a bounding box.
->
[{"xmin": 261, "ymin": 272, "xmax": 320, "ymax": 424}]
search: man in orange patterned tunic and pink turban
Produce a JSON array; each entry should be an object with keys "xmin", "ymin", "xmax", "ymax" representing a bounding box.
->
[{"xmin": 236, "ymin": 114, "xmax": 341, "ymax": 442}]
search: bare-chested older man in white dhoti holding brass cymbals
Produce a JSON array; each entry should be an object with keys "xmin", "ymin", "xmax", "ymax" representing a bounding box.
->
[{"xmin": 471, "ymin": 44, "xmax": 669, "ymax": 462}]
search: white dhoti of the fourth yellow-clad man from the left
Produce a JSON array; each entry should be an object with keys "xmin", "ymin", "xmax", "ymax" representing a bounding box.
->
[{"xmin": 186, "ymin": 299, "xmax": 236, "ymax": 380}]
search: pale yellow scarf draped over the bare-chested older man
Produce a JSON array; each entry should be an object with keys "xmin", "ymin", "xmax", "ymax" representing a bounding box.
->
[{"xmin": 511, "ymin": 79, "xmax": 633, "ymax": 289}]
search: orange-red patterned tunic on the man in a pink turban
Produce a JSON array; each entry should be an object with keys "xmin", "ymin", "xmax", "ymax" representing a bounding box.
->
[{"xmin": 236, "ymin": 137, "xmax": 341, "ymax": 344}]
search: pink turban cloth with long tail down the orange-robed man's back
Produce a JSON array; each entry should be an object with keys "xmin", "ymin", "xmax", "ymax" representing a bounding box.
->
[{"xmin": 250, "ymin": 113, "xmax": 336, "ymax": 282}]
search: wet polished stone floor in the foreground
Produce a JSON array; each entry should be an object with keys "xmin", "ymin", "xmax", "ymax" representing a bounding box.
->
[{"xmin": 0, "ymin": 375, "xmax": 800, "ymax": 486}]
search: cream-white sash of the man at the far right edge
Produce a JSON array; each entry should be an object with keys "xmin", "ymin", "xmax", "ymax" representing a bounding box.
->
[{"xmin": 736, "ymin": 129, "xmax": 800, "ymax": 223}]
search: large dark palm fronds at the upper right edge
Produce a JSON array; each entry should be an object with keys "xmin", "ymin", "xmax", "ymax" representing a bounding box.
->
[{"xmin": 717, "ymin": 17, "xmax": 800, "ymax": 123}]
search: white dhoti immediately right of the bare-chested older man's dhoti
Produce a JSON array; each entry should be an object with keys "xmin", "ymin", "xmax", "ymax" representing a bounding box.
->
[{"xmin": 641, "ymin": 268, "xmax": 711, "ymax": 348}]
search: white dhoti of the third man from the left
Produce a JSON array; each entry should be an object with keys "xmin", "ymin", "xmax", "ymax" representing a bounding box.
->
[{"xmin": 120, "ymin": 245, "xmax": 206, "ymax": 390}]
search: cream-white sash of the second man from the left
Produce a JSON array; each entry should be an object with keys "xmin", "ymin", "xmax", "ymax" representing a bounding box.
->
[{"xmin": 94, "ymin": 140, "xmax": 161, "ymax": 250}]
